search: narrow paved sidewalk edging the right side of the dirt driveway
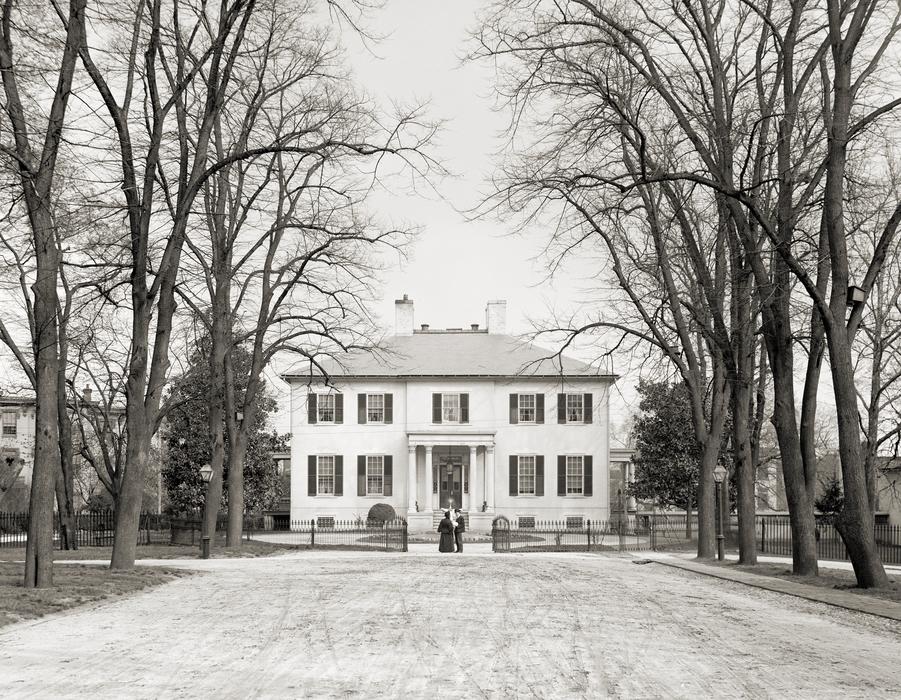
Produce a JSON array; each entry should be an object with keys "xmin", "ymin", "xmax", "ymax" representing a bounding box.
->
[{"xmin": 635, "ymin": 552, "xmax": 901, "ymax": 622}]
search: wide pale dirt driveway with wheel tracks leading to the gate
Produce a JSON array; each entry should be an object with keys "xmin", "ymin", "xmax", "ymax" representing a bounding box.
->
[{"xmin": 0, "ymin": 547, "xmax": 901, "ymax": 699}]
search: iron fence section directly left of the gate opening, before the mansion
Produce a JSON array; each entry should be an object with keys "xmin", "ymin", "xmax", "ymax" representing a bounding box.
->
[{"xmin": 248, "ymin": 518, "xmax": 408, "ymax": 552}]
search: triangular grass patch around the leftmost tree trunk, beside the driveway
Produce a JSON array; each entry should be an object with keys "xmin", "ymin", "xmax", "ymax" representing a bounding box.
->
[{"xmin": 0, "ymin": 562, "xmax": 191, "ymax": 627}]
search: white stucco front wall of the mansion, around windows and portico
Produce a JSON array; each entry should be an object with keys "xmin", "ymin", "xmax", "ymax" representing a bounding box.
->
[{"xmin": 291, "ymin": 379, "xmax": 610, "ymax": 522}]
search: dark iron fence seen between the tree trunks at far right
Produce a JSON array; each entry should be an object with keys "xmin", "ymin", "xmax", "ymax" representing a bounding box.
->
[{"xmin": 756, "ymin": 516, "xmax": 901, "ymax": 564}]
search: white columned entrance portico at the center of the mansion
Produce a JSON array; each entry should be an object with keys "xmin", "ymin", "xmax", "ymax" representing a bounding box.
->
[{"xmin": 406, "ymin": 431, "xmax": 495, "ymax": 530}]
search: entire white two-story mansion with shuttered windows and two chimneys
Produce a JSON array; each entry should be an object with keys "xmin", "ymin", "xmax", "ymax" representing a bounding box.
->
[{"xmin": 284, "ymin": 296, "xmax": 615, "ymax": 531}]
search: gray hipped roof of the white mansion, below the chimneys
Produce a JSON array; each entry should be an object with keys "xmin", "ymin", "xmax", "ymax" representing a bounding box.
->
[{"xmin": 282, "ymin": 331, "xmax": 616, "ymax": 381}]
